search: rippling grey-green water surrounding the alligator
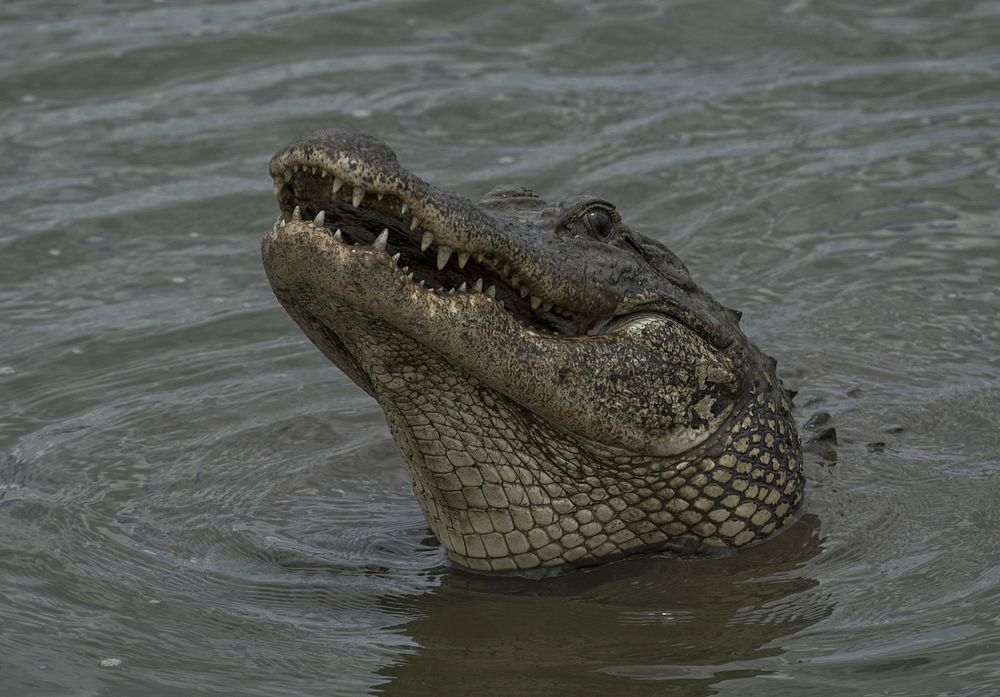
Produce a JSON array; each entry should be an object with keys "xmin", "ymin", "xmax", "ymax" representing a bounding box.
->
[{"xmin": 0, "ymin": 0, "xmax": 1000, "ymax": 697}]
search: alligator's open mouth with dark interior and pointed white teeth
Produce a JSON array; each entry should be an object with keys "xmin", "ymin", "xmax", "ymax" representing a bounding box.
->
[{"xmin": 271, "ymin": 157, "xmax": 592, "ymax": 336}]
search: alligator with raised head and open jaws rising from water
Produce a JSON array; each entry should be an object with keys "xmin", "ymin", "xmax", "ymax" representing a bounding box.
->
[{"xmin": 262, "ymin": 129, "xmax": 804, "ymax": 576}]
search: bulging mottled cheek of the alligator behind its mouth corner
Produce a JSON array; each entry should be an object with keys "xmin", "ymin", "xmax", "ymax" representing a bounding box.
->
[{"xmin": 438, "ymin": 319, "xmax": 740, "ymax": 456}]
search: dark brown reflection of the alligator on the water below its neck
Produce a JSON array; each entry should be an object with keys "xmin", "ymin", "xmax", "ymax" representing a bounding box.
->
[{"xmin": 380, "ymin": 516, "xmax": 832, "ymax": 695}]
